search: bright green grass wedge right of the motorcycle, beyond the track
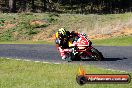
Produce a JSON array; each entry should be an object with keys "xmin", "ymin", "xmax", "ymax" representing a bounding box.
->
[{"xmin": 92, "ymin": 36, "xmax": 132, "ymax": 46}]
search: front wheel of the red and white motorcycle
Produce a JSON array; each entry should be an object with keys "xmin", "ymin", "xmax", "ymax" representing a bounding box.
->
[{"xmin": 91, "ymin": 48, "xmax": 104, "ymax": 61}]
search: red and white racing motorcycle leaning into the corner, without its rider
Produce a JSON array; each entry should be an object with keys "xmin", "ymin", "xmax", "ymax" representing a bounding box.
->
[{"xmin": 65, "ymin": 34, "xmax": 104, "ymax": 61}]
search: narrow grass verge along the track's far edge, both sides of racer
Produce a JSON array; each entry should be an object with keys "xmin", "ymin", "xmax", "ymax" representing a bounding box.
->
[{"xmin": 0, "ymin": 36, "xmax": 132, "ymax": 46}]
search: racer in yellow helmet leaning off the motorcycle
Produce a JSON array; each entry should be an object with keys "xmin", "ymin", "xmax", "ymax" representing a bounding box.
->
[{"xmin": 55, "ymin": 28, "xmax": 78, "ymax": 60}]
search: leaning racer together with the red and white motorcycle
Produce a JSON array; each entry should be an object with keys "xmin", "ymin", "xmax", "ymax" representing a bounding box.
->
[{"xmin": 55, "ymin": 28, "xmax": 104, "ymax": 62}]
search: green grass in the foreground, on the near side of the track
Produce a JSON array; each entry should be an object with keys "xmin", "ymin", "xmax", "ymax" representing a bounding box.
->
[{"xmin": 0, "ymin": 58, "xmax": 132, "ymax": 88}]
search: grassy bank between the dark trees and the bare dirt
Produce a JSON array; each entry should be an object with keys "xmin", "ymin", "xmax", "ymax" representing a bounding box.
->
[{"xmin": 0, "ymin": 13, "xmax": 132, "ymax": 41}]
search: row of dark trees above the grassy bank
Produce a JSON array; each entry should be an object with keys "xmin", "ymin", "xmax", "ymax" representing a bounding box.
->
[{"xmin": 0, "ymin": 0, "xmax": 132, "ymax": 14}]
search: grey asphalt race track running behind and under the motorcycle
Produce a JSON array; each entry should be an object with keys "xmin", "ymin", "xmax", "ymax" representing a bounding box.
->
[{"xmin": 0, "ymin": 44, "xmax": 132, "ymax": 71}]
